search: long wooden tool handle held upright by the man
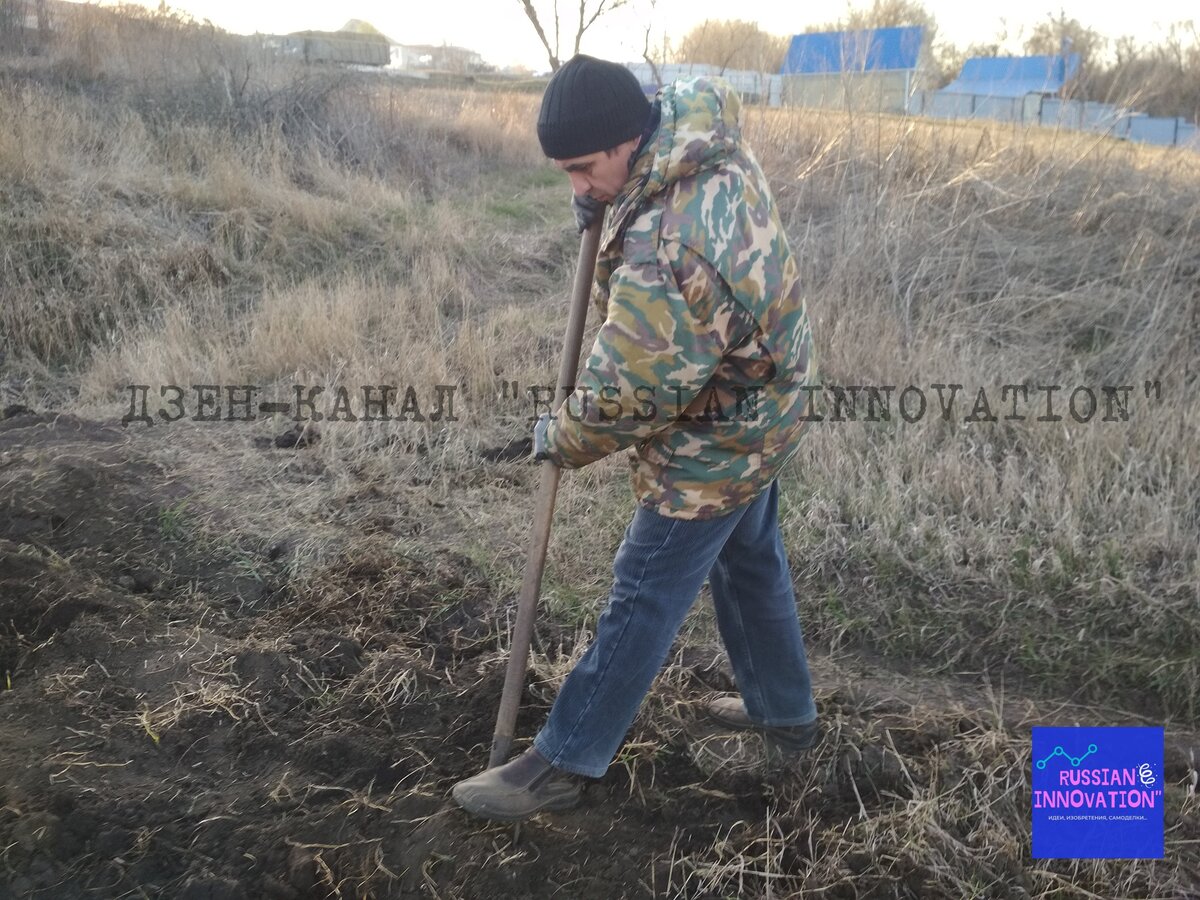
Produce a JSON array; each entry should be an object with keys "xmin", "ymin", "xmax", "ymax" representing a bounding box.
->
[{"xmin": 487, "ymin": 221, "xmax": 601, "ymax": 768}]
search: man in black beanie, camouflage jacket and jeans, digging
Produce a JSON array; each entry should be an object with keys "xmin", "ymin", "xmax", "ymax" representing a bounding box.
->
[{"xmin": 454, "ymin": 55, "xmax": 820, "ymax": 821}]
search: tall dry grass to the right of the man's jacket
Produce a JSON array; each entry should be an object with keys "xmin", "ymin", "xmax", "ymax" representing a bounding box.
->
[{"xmin": 734, "ymin": 107, "xmax": 1200, "ymax": 720}]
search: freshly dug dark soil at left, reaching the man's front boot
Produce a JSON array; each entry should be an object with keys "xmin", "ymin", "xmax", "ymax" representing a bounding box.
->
[{"xmin": 0, "ymin": 415, "xmax": 777, "ymax": 899}]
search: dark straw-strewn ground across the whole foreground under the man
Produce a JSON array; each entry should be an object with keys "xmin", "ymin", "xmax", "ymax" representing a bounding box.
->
[{"xmin": 0, "ymin": 414, "xmax": 1200, "ymax": 900}]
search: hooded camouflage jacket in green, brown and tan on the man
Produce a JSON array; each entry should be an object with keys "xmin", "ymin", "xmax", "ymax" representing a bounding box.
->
[{"xmin": 546, "ymin": 78, "xmax": 815, "ymax": 518}]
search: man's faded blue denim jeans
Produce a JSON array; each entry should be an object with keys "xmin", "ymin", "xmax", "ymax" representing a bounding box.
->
[{"xmin": 534, "ymin": 482, "xmax": 817, "ymax": 778}]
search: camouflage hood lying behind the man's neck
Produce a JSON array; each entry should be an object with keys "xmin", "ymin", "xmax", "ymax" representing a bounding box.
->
[{"xmin": 604, "ymin": 78, "xmax": 742, "ymax": 244}]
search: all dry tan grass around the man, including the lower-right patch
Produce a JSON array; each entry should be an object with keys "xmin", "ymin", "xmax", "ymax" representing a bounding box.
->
[{"xmin": 0, "ymin": 10, "xmax": 1200, "ymax": 898}]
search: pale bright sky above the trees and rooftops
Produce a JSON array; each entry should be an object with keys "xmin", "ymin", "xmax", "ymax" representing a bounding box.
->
[{"xmin": 79, "ymin": 0, "xmax": 1200, "ymax": 71}]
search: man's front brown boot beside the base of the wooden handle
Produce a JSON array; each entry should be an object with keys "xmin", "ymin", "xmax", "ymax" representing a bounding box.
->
[{"xmin": 451, "ymin": 748, "xmax": 583, "ymax": 822}]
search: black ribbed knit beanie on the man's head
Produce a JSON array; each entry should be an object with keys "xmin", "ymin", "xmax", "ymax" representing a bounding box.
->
[{"xmin": 538, "ymin": 53, "xmax": 650, "ymax": 160}]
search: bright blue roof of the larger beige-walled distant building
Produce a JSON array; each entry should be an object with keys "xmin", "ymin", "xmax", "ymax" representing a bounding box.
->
[{"xmin": 779, "ymin": 25, "xmax": 924, "ymax": 74}]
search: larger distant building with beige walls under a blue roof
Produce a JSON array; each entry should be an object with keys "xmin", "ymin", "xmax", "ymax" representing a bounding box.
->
[{"xmin": 780, "ymin": 26, "xmax": 925, "ymax": 113}]
